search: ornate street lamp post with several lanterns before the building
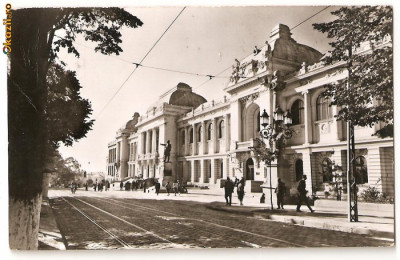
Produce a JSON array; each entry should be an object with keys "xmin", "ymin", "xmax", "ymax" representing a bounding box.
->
[{"xmin": 249, "ymin": 106, "xmax": 292, "ymax": 210}]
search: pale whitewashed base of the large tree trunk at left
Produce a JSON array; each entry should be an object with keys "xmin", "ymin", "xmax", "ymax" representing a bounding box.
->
[{"xmin": 8, "ymin": 194, "xmax": 42, "ymax": 250}]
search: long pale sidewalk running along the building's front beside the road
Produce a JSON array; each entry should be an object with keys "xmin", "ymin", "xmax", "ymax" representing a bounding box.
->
[{"xmin": 44, "ymin": 189, "xmax": 395, "ymax": 244}]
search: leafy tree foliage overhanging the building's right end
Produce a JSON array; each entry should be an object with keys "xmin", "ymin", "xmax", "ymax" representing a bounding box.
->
[{"xmin": 313, "ymin": 6, "xmax": 394, "ymax": 137}]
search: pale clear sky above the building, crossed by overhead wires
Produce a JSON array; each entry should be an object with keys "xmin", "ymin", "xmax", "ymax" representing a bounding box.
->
[{"xmin": 51, "ymin": 6, "xmax": 337, "ymax": 172}]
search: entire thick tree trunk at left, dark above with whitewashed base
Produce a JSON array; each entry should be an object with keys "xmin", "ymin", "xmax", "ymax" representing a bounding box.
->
[{"xmin": 7, "ymin": 9, "xmax": 57, "ymax": 250}]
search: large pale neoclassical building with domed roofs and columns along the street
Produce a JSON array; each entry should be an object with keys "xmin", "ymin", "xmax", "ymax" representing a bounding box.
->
[{"xmin": 107, "ymin": 24, "xmax": 394, "ymax": 196}]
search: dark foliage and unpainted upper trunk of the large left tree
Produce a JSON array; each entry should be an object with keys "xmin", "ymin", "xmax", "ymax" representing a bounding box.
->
[{"xmin": 8, "ymin": 8, "xmax": 142, "ymax": 200}]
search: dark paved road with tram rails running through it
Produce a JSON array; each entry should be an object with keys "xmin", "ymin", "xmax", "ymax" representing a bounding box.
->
[{"xmin": 50, "ymin": 193, "xmax": 392, "ymax": 249}]
